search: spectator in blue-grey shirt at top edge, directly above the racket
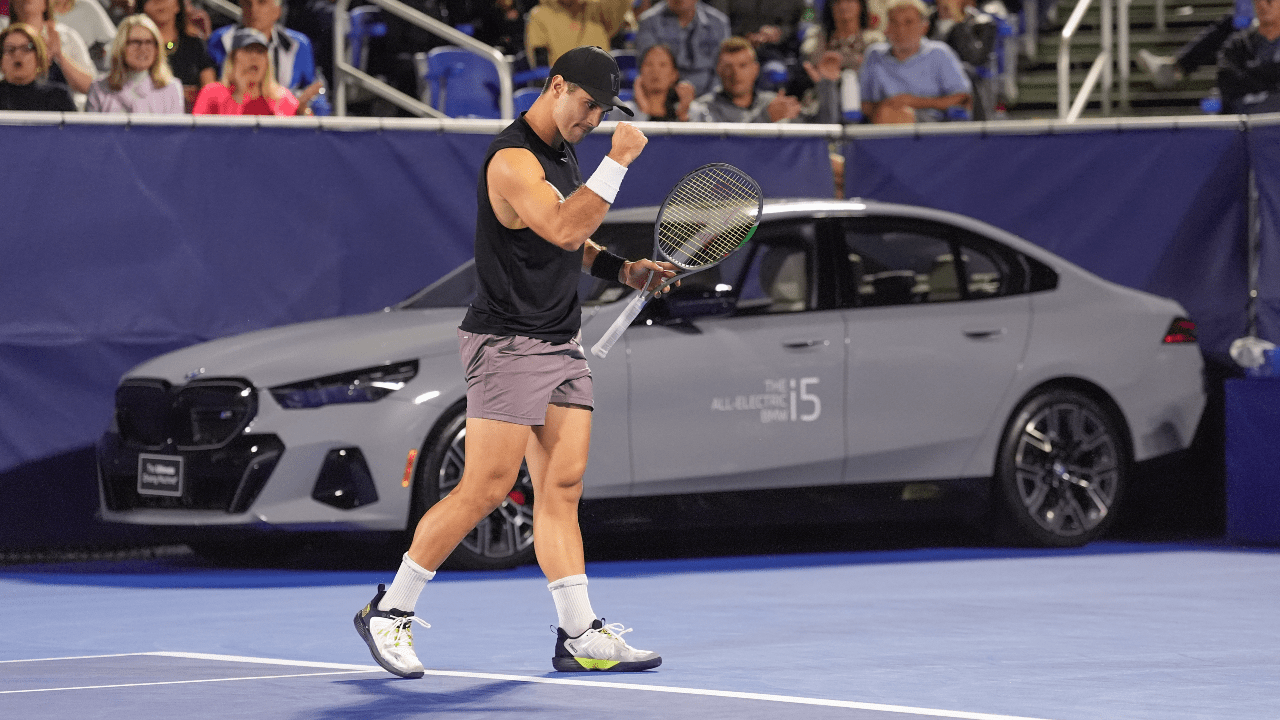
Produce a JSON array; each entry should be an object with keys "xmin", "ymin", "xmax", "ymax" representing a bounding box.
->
[{"xmin": 636, "ymin": 0, "xmax": 731, "ymax": 95}]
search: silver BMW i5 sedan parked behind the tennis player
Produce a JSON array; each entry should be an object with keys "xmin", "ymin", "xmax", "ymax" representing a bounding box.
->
[{"xmin": 99, "ymin": 200, "xmax": 1204, "ymax": 568}]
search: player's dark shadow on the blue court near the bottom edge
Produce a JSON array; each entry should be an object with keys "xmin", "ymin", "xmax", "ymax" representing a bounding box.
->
[{"xmin": 297, "ymin": 675, "xmax": 560, "ymax": 720}]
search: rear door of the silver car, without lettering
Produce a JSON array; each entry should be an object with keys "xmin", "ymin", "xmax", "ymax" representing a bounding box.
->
[{"xmin": 842, "ymin": 218, "xmax": 1030, "ymax": 483}]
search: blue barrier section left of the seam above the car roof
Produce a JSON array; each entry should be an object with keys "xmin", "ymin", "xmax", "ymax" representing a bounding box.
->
[{"xmin": 0, "ymin": 126, "xmax": 835, "ymax": 481}]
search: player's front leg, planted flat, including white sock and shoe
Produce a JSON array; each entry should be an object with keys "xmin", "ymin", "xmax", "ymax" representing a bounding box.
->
[{"xmin": 525, "ymin": 404, "xmax": 662, "ymax": 671}]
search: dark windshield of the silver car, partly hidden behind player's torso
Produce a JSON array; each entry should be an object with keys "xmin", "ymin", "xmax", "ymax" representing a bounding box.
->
[{"xmin": 396, "ymin": 223, "xmax": 653, "ymax": 310}]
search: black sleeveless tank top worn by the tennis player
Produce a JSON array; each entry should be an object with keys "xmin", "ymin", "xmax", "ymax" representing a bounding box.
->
[{"xmin": 461, "ymin": 114, "xmax": 582, "ymax": 343}]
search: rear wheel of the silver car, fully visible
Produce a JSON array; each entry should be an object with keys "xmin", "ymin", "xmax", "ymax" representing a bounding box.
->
[{"xmin": 995, "ymin": 389, "xmax": 1129, "ymax": 547}]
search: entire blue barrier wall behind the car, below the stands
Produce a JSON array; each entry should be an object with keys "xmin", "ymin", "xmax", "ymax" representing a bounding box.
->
[{"xmin": 0, "ymin": 116, "xmax": 1280, "ymax": 547}]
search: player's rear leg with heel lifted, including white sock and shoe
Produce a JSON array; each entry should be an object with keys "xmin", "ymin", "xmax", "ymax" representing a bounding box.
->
[{"xmin": 356, "ymin": 418, "xmax": 530, "ymax": 678}]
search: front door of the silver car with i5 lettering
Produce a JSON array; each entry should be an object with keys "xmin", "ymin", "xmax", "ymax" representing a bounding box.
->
[{"xmin": 623, "ymin": 219, "xmax": 845, "ymax": 495}]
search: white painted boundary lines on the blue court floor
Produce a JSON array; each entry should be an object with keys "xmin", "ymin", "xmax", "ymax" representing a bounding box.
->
[{"xmin": 0, "ymin": 651, "xmax": 1059, "ymax": 720}]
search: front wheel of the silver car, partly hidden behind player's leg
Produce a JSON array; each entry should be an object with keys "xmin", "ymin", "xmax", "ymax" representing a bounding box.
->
[{"xmin": 410, "ymin": 406, "xmax": 535, "ymax": 570}]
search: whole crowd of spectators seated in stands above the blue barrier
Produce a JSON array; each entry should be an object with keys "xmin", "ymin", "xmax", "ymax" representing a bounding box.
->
[{"xmin": 0, "ymin": 0, "xmax": 1280, "ymax": 123}]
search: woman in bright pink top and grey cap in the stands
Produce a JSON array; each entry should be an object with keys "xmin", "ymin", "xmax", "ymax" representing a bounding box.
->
[{"xmin": 191, "ymin": 27, "xmax": 300, "ymax": 115}]
